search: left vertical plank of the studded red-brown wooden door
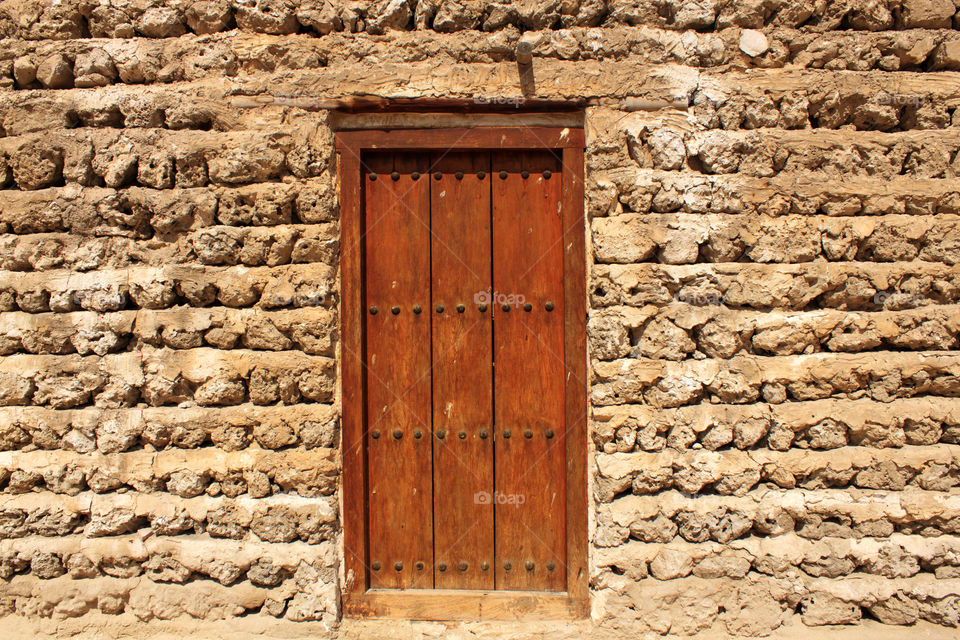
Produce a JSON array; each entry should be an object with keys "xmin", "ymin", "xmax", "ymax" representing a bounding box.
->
[{"xmin": 362, "ymin": 153, "xmax": 433, "ymax": 589}]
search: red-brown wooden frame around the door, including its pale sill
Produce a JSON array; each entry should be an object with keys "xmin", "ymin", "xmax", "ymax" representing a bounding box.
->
[{"xmin": 335, "ymin": 126, "xmax": 590, "ymax": 620}]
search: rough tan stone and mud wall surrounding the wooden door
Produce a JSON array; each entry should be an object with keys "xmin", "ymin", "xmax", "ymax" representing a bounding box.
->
[{"xmin": 0, "ymin": 0, "xmax": 960, "ymax": 637}]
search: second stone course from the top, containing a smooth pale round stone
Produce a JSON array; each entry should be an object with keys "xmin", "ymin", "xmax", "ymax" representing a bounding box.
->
[{"xmin": 0, "ymin": 22, "xmax": 960, "ymax": 90}]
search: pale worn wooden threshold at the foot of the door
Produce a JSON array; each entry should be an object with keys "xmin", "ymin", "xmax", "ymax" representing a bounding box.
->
[{"xmin": 343, "ymin": 589, "xmax": 587, "ymax": 622}]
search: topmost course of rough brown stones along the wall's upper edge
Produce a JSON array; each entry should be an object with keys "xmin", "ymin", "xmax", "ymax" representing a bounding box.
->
[{"xmin": 0, "ymin": 0, "xmax": 960, "ymax": 44}]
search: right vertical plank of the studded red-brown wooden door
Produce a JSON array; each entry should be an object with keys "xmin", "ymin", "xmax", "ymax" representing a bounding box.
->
[{"xmin": 491, "ymin": 151, "xmax": 567, "ymax": 591}]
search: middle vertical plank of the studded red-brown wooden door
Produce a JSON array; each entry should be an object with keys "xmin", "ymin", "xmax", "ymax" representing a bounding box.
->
[{"xmin": 430, "ymin": 152, "xmax": 494, "ymax": 589}]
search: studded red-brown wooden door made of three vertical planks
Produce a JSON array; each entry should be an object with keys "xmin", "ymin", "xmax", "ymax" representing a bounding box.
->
[{"xmin": 341, "ymin": 129, "xmax": 586, "ymax": 616}]
